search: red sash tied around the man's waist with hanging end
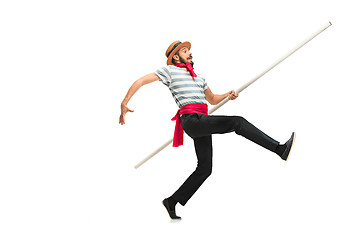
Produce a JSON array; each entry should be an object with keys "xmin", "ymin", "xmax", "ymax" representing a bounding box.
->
[{"xmin": 171, "ymin": 103, "xmax": 208, "ymax": 147}]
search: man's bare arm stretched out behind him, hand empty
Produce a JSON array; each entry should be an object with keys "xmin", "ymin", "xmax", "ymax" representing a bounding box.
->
[{"xmin": 119, "ymin": 73, "xmax": 160, "ymax": 125}]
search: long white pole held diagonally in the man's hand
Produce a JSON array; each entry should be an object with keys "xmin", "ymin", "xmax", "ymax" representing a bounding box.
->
[{"xmin": 135, "ymin": 22, "xmax": 332, "ymax": 169}]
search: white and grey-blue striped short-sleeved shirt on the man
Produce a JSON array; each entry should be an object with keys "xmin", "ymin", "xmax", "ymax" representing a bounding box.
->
[{"xmin": 155, "ymin": 65, "xmax": 208, "ymax": 108}]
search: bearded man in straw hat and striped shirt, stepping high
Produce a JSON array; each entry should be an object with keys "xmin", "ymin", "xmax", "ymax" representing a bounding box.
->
[{"xmin": 119, "ymin": 41, "xmax": 295, "ymax": 220}]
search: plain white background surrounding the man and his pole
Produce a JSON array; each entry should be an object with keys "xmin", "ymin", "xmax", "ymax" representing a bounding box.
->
[{"xmin": 0, "ymin": 0, "xmax": 360, "ymax": 240}]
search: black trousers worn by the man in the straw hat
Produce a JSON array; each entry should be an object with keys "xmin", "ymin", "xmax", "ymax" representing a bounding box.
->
[{"xmin": 172, "ymin": 113, "xmax": 279, "ymax": 206}]
